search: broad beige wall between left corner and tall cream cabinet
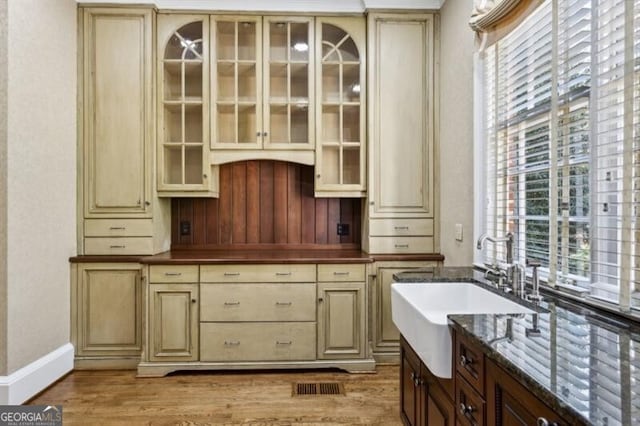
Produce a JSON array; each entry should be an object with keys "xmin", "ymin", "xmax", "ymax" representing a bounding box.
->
[{"xmin": 5, "ymin": 0, "xmax": 76, "ymax": 374}]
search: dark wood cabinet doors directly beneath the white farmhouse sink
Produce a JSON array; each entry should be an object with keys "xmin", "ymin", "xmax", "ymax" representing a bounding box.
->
[{"xmin": 400, "ymin": 337, "xmax": 455, "ymax": 426}]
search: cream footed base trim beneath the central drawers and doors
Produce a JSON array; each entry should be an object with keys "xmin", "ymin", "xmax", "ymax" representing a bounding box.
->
[{"xmin": 138, "ymin": 358, "xmax": 376, "ymax": 377}]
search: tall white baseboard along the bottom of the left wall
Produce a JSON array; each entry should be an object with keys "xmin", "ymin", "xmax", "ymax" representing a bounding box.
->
[{"xmin": 0, "ymin": 343, "xmax": 73, "ymax": 405}]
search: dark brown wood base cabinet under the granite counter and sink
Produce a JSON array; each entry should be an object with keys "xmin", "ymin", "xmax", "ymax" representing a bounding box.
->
[{"xmin": 400, "ymin": 332, "xmax": 569, "ymax": 426}]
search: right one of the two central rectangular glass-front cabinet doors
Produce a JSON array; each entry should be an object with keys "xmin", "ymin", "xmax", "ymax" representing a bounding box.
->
[{"xmin": 263, "ymin": 17, "xmax": 315, "ymax": 150}]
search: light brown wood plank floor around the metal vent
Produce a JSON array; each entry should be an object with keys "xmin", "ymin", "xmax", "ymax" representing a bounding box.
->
[{"xmin": 29, "ymin": 366, "xmax": 401, "ymax": 426}]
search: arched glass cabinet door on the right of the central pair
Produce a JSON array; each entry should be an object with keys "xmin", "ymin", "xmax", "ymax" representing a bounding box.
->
[{"xmin": 315, "ymin": 18, "xmax": 366, "ymax": 197}]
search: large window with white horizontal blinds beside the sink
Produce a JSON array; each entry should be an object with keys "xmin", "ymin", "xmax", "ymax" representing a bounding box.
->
[{"xmin": 482, "ymin": 0, "xmax": 640, "ymax": 309}]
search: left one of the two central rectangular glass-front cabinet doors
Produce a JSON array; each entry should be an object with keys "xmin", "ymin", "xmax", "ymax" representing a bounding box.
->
[{"xmin": 211, "ymin": 16, "xmax": 263, "ymax": 149}]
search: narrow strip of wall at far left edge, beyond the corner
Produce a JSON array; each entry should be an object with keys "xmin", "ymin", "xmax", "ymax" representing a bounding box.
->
[{"xmin": 0, "ymin": 1, "xmax": 7, "ymax": 376}]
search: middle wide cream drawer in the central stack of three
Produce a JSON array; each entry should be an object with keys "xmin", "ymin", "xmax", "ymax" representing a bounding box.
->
[{"xmin": 200, "ymin": 283, "xmax": 316, "ymax": 321}]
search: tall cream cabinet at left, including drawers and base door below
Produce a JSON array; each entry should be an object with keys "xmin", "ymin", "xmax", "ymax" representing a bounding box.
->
[{"xmin": 71, "ymin": 7, "xmax": 170, "ymax": 368}]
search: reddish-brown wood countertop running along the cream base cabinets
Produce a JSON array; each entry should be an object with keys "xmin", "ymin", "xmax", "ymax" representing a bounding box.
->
[{"xmin": 69, "ymin": 249, "xmax": 444, "ymax": 265}]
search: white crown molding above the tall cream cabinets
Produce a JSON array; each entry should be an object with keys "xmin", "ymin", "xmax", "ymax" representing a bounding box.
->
[{"xmin": 76, "ymin": 0, "xmax": 445, "ymax": 13}]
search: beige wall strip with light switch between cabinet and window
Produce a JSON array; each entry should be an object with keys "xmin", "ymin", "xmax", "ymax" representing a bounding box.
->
[{"xmin": 440, "ymin": 0, "xmax": 475, "ymax": 266}]
